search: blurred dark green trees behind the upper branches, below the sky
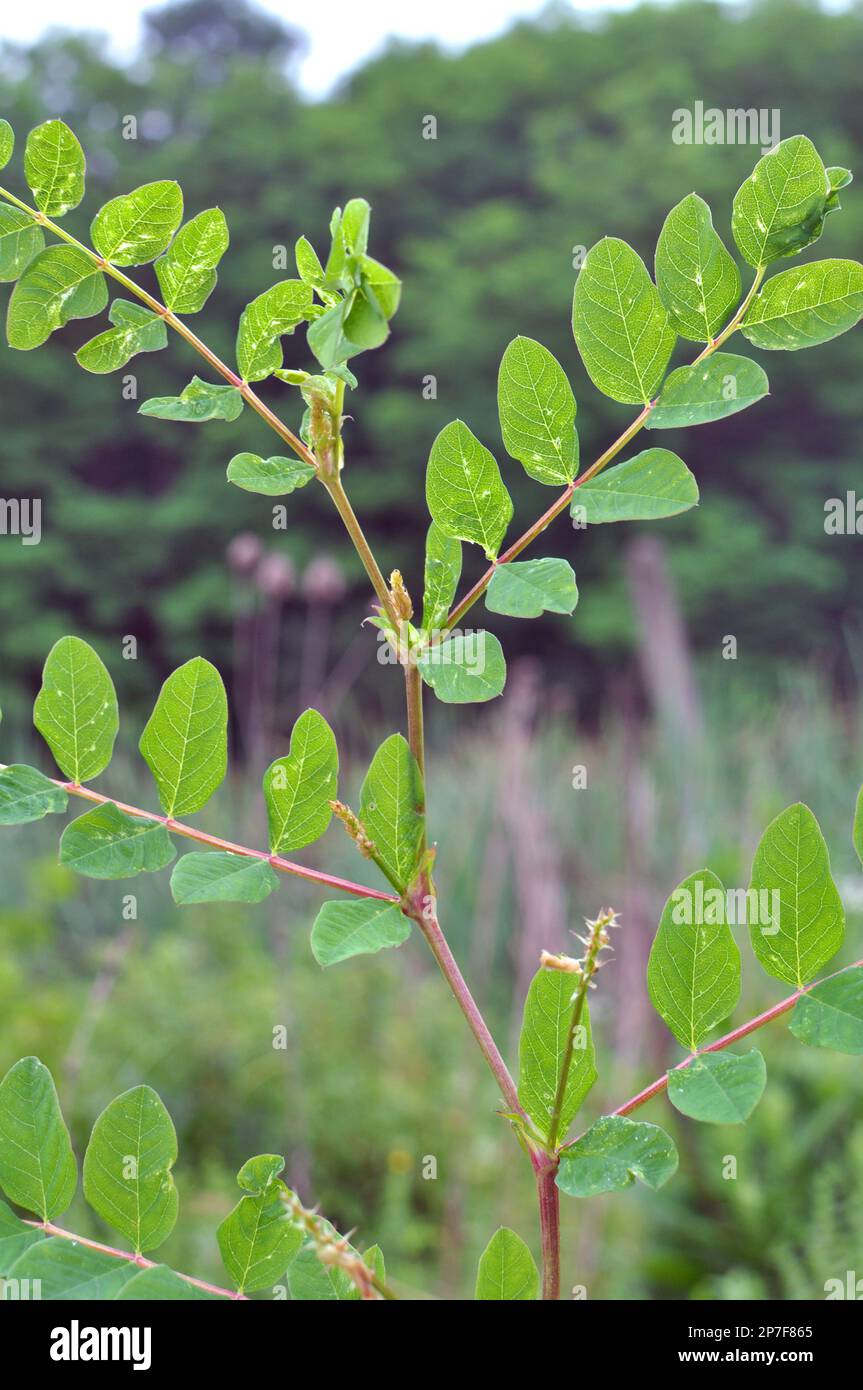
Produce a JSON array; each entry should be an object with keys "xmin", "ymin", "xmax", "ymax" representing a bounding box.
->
[{"xmin": 0, "ymin": 0, "xmax": 863, "ymax": 719}]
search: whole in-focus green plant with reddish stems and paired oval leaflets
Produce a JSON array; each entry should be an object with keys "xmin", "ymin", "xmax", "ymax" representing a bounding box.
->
[{"xmin": 0, "ymin": 120, "xmax": 863, "ymax": 1300}]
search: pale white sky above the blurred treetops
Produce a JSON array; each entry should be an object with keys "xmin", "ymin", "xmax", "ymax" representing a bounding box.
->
[{"xmin": 0, "ymin": 0, "xmax": 655, "ymax": 96}]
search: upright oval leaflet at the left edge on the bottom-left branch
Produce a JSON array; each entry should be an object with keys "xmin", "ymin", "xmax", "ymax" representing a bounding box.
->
[{"xmin": 0, "ymin": 1056, "xmax": 78, "ymax": 1220}]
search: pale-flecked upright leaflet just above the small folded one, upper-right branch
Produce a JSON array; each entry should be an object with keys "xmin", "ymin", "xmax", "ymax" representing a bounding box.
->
[{"xmin": 425, "ymin": 420, "xmax": 513, "ymax": 560}]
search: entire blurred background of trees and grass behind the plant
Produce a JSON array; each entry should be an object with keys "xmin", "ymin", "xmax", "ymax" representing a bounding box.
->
[{"xmin": 0, "ymin": 0, "xmax": 863, "ymax": 1298}]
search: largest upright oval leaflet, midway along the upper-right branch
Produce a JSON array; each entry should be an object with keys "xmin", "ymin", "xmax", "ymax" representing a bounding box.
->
[{"xmin": 573, "ymin": 236, "xmax": 675, "ymax": 404}]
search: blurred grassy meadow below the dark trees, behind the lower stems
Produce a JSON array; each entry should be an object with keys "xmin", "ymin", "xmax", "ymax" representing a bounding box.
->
[{"xmin": 0, "ymin": 681, "xmax": 863, "ymax": 1298}]
